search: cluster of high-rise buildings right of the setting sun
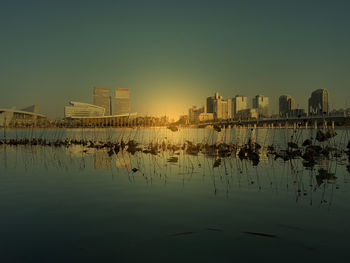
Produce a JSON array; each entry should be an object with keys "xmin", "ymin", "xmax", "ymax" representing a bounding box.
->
[{"xmin": 188, "ymin": 89, "xmax": 338, "ymax": 123}]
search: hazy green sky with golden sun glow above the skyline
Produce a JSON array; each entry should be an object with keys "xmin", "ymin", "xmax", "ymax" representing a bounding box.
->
[{"xmin": 0, "ymin": 0, "xmax": 350, "ymax": 118}]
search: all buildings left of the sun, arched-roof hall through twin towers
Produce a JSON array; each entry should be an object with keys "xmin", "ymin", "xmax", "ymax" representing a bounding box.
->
[{"xmin": 0, "ymin": 87, "xmax": 136, "ymax": 127}]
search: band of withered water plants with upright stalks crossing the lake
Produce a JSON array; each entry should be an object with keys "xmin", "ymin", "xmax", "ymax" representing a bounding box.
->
[{"xmin": 0, "ymin": 125, "xmax": 350, "ymax": 169}]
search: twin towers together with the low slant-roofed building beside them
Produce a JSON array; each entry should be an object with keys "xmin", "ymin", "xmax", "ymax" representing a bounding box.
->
[{"xmin": 64, "ymin": 87, "xmax": 130, "ymax": 119}]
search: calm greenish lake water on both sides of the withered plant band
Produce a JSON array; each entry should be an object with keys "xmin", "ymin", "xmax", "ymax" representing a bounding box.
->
[{"xmin": 0, "ymin": 129, "xmax": 350, "ymax": 262}]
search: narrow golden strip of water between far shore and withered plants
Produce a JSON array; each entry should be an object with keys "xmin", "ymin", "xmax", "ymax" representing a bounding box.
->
[{"xmin": 0, "ymin": 128, "xmax": 350, "ymax": 148}]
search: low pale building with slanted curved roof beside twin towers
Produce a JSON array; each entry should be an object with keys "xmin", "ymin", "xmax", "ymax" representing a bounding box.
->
[{"xmin": 64, "ymin": 101, "xmax": 105, "ymax": 119}]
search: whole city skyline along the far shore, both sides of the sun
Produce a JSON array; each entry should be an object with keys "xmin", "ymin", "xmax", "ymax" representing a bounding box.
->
[{"xmin": 3, "ymin": 86, "xmax": 350, "ymax": 121}]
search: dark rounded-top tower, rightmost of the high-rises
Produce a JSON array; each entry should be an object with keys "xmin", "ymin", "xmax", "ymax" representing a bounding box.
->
[{"xmin": 308, "ymin": 89, "xmax": 329, "ymax": 115}]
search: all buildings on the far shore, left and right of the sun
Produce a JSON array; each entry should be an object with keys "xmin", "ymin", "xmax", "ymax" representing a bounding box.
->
[{"xmin": 0, "ymin": 87, "xmax": 350, "ymax": 127}]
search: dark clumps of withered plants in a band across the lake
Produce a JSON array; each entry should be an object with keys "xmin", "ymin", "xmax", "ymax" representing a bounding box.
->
[{"xmin": 0, "ymin": 124, "xmax": 350, "ymax": 173}]
